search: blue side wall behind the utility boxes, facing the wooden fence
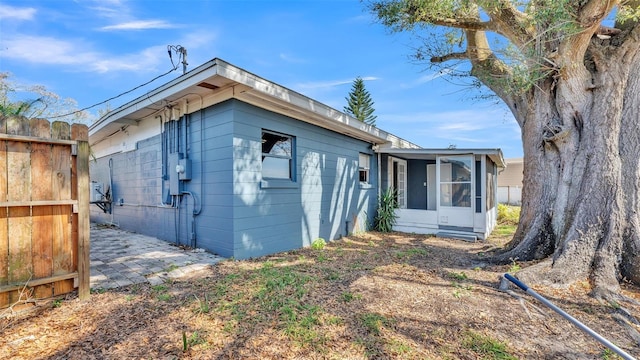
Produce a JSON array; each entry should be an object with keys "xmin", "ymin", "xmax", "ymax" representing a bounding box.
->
[{"xmin": 91, "ymin": 103, "xmax": 238, "ymax": 256}]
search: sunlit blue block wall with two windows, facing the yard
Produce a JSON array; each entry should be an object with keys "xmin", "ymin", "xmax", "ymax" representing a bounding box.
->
[{"xmin": 233, "ymin": 102, "xmax": 377, "ymax": 258}]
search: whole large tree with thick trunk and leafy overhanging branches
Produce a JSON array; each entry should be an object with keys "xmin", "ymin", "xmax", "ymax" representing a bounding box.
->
[{"xmin": 368, "ymin": 0, "xmax": 640, "ymax": 296}]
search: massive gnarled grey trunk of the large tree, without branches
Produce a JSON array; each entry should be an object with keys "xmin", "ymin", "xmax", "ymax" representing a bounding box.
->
[{"xmin": 497, "ymin": 33, "xmax": 640, "ymax": 296}]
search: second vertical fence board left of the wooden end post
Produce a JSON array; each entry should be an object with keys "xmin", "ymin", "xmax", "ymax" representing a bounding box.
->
[{"xmin": 30, "ymin": 119, "xmax": 53, "ymax": 298}]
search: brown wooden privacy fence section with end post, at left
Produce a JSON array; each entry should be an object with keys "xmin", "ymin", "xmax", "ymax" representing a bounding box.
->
[{"xmin": 0, "ymin": 115, "xmax": 90, "ymax": 308}]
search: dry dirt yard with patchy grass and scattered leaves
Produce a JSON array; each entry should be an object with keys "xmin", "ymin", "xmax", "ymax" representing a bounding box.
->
[{"xmin": 0, "ymin": 233, "xmax": 640, "ymax": 359}]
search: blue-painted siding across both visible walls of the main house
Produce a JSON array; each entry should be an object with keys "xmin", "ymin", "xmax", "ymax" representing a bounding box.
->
[{"xmin": 91, "ymin": 100, "xmax": 377, "ymax": 259}]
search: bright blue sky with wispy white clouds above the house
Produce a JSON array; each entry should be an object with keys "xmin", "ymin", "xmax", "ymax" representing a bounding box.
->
[{"xmin": 0, "ymin": 0, "xmax": 522, "ymax": 157}]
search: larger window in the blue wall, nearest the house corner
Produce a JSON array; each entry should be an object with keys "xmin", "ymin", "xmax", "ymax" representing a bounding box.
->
[{"xmin": 262, "ymin": 130, "xmax": 294, "ymax": 180}]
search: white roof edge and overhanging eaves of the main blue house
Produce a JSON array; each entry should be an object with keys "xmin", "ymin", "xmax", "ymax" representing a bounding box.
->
[{"xmin": 89, "ymin": 58, "xmax": 419, "ymax": 148}]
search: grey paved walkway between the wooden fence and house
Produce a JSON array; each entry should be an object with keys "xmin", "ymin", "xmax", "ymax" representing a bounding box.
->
[{"xmin": 90, "ymin": 223, "xmax": 223, "ymax": 289}]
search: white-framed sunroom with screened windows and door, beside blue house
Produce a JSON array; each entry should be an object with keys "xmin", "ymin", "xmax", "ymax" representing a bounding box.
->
[{"xmin": 378, "ymin": 148, "xmax": 505, "ymax": 241}]
